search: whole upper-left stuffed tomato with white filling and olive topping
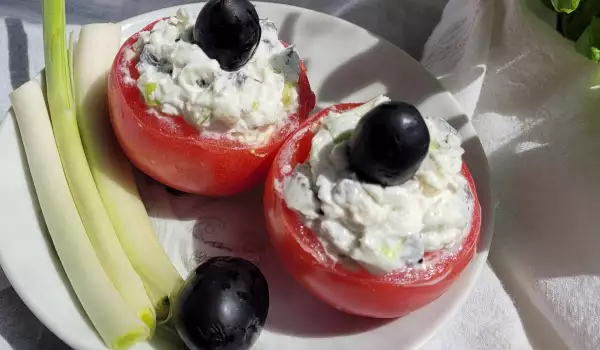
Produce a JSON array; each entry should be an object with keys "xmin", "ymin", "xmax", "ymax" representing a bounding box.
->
[{"xmin": 108, "ymin": 6, "xmax": 315, "ymax": 196}]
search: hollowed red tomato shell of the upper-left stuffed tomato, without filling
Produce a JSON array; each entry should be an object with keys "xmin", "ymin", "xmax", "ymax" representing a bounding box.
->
[{"xmin": 108, "ymin": 22, "xmax": 315, "ymax": 196}]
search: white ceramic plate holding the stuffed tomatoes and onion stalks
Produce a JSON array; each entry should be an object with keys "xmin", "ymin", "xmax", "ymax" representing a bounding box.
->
[{"xmin": 0, "ymin": 3, "xmax": 493, "ymax": 350}]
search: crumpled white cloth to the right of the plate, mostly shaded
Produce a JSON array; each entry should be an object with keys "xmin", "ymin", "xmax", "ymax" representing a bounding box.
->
[{"xmin": 422, "ymin": 0, "xmax": 600, "ymax": 349}]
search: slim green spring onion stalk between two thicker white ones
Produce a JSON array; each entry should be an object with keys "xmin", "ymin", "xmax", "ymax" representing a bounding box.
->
[{"xmin": 42, "ymin": 0, "xmax": 156, "ymax": 331}]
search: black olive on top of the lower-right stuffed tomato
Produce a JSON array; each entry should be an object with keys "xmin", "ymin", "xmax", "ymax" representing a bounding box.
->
[{"xmin": 348, "ymin": 102, "xmax": 430, "ymax": 186}]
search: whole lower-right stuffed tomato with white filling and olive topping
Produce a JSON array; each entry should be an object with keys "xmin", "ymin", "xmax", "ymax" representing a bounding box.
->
[{"xmin": 264, "ymin": 96, "xmax": 481, "ymax": 318}]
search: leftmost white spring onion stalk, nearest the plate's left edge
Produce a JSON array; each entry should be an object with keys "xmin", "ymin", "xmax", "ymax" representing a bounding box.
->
[{"xmin": 10, "ymin": 81, "xmax": 149, "ymax": 349}]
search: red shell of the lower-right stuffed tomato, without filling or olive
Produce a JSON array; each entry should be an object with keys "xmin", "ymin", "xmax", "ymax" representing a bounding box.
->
[{"xmin": 264, "ymin": 104, "xmax": 481, "ymax": 318}]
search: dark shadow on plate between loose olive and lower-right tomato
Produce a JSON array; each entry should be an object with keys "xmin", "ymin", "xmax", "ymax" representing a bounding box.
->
[{"xmin": 152, "ymin": 178, "xmax": 389, "ymax": 337}]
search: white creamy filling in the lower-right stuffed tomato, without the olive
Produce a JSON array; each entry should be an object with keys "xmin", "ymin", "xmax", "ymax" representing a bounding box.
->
[{"xmin": 283, "ymin": 96, "xmax": 473, "ymax": 274}]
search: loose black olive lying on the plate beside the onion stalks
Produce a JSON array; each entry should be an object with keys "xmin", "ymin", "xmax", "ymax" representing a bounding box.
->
[{"xmin": 174, "ymin": 257, "xmax": 269, "ymax": 350}]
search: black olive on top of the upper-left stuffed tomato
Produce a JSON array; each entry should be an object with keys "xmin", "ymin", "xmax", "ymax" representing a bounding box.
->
[{"xmin": 194, "ymin": 0, "xmax": 261, "ymax": 71}]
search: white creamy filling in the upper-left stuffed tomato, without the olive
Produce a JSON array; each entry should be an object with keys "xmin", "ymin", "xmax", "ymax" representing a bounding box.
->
[{"xmin": 134, "ymin": 9, "xmax": 300, "ymax": 143}]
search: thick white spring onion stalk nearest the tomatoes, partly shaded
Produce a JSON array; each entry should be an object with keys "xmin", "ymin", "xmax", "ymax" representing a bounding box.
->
[{"xmin": 73, "ymin": 23, "xmax": 183, "ymax": 319}]
